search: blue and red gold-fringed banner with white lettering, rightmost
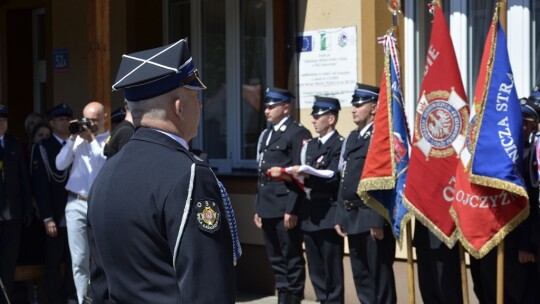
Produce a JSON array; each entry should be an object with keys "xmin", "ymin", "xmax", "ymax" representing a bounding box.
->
[{"xmin": 452, "ymin": 11, "xmax": 529, "ymax": 258}]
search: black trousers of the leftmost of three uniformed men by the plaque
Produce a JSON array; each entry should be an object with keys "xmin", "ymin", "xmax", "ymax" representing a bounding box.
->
[{"xmin": 262, "ymin": 218, "xmax": 306, "ymax": 298}]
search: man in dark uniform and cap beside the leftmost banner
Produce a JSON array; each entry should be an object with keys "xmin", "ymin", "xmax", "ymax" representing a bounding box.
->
[{"xmin": 335, "ymin": 84, "xmax": 396, "ymax": 303}]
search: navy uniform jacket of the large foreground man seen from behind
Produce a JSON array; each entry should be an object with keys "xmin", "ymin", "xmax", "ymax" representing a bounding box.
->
[{"xmin": 88, "ymin": 128, "xmax": 236, "ymax": 304}]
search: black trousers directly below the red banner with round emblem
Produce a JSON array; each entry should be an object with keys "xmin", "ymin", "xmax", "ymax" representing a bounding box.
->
[{"xmin": 415, "ymin": 243, "xmax": 463, "ymax": 304}]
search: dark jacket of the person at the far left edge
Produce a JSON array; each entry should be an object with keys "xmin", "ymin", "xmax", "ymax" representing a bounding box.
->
[{"xmin": 0, "ymin": 134, "xmax": 32, "ymax": 220}]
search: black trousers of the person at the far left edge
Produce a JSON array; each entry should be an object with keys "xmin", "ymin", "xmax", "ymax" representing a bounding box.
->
[{"xmin": 0, "ymin": 220, "xmax": 22, "ymax": 303}]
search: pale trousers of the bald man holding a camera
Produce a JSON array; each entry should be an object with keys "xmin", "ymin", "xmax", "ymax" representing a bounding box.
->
[{"xmin": 66, "ymin": 196, "xmax": 90, "ymax": 304}]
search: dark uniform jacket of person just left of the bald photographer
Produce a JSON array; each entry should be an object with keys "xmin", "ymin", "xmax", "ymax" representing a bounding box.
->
[{"xmin": 31, "ymin": 136, "xmax": 69, "ymax": 225}]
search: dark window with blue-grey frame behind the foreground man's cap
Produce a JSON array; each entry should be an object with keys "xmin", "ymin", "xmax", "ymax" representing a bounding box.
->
[{"xmin": 166, "ymin": 0, "xmax": 273, "ymax": 173}]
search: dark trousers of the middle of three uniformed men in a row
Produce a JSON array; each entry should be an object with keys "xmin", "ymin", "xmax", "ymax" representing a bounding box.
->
[{"xmin": 304, "ymin": 229, "xmax": 344, "ymax": 304}]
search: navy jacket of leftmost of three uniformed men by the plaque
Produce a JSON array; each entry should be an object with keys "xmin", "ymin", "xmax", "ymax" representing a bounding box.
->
[{"xmin": 255, "ymin": 117, "xmax": 311, "ymax": 218}]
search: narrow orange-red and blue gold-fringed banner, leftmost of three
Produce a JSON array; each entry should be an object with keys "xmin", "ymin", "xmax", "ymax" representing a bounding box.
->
[{"xmin": 358, "ymin": 30, "xmax": 410, "ymax": 244}]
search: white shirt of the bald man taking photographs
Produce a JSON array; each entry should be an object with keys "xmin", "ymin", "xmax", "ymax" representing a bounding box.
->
[{"xmin": 56, "ymin": 131, "xmax": 109, "ymax": 196}]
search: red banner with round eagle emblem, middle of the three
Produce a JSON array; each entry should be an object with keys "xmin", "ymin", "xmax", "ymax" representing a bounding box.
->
[{"xmin": 404, "ymin": 5, "xmax": 469, "ymax": 247}]
